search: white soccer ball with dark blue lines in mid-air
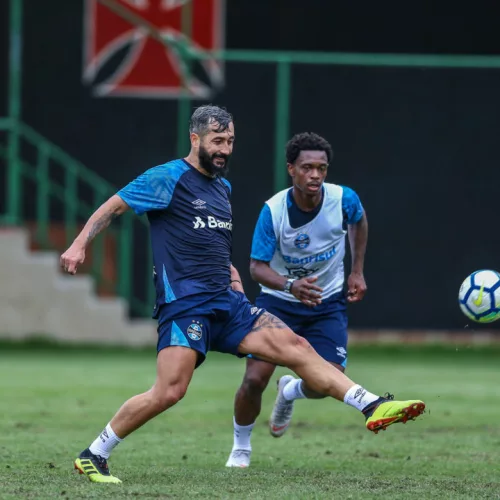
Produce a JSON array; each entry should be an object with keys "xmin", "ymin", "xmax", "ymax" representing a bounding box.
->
[{"xmin": 458, "ymin": 269, "xmax": 500, "ymax": 323}]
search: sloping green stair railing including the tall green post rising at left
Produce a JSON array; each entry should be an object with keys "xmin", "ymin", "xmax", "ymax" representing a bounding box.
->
[{"xmin": 0, "ymin": 0, "xmax": 154, "ymax": 316}]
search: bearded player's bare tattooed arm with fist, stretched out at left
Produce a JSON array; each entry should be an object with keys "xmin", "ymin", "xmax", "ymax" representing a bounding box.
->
[{"xmin": 60, "ymin": 194, "xmax": 129, "ymax": 274}]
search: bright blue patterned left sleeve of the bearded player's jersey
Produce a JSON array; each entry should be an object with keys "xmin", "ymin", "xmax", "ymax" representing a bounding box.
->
[{"xmin": 116, "ymin": 161, "xmax": 189, "ymax": 215}]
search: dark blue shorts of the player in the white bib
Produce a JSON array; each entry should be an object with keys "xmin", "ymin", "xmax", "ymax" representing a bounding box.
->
[{"xmin": 255, "ymin": 291, "xmax": 347, "ymax": 367}]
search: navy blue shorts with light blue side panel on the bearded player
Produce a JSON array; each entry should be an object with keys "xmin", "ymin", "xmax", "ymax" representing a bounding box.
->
[{"xmin": 156, "ymin": 288, "xmax": 265, "ymax": 366}]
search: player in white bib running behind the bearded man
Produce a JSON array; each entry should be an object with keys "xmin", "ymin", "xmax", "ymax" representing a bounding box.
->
[{"xmin": 226, "ymin": 133, "xmax": 368, "ymax": 467}]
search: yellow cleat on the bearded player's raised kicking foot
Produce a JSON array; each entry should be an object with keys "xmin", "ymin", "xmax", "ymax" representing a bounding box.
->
[{"xmin": 363, "ymin": 394, "xmax": 425, "ymax": 434}]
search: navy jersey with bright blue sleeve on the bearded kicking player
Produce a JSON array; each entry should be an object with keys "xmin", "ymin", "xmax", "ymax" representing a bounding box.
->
[{"xmin": 117, "ymin": 160, "xmax": 233, "ymax": 314}]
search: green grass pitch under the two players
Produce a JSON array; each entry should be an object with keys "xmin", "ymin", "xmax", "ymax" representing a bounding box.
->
[{"xmin": 0, "ymin": 344, "xmax": 500, "ymax": 499}]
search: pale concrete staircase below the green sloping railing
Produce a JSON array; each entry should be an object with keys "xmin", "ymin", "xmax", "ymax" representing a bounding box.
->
[{"xmin": 0, "ymin": 229, "xmax": 156, "ymax": 346}]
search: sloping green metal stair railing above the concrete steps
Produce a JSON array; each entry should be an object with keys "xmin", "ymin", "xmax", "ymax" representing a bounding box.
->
[{"xmin": 0, "ymin": 119, "xmax": 154, "ymax": 316}]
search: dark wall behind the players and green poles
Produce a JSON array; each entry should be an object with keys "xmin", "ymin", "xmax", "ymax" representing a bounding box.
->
[{"xmin": 0, "ymin": 0, "xmax": 500, "ymax": 331}]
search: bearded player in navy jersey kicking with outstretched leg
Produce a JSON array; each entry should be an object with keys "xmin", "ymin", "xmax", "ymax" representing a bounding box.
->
[{"xmin": 61, "ymin": 106, "xmax": 425, "ymax": 483}]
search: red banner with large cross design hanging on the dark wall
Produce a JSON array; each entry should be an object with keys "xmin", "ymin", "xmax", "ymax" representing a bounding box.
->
[{"xmin": 83, "ymin": 0, "xmax": 225, "ymax": 98}]
